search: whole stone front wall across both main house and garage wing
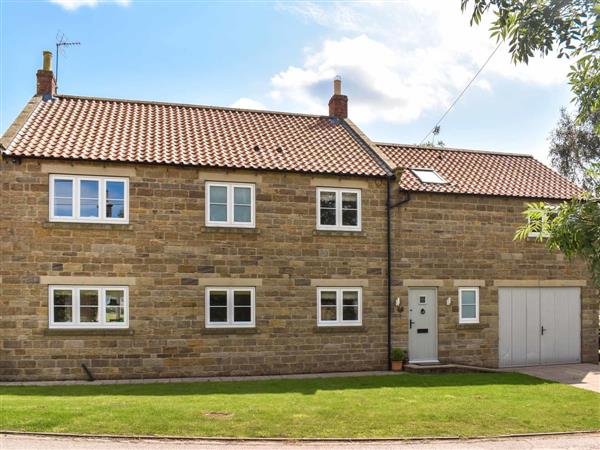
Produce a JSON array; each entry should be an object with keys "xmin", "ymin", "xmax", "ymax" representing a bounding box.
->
[{"xmin": 0, "ymin": 159, "xmax": 598, "ymax": 380}]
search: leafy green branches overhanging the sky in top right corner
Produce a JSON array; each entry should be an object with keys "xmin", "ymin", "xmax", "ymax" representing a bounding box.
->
[{"xmin": 461, "ymin": 0, "xmax": 600, "ymax": 134}]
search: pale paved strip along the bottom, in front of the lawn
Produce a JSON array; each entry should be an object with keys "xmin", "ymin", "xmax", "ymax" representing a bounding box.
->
[{"xmin": 0, "ymin": 433, "xmax": 600, "ymax": 450}]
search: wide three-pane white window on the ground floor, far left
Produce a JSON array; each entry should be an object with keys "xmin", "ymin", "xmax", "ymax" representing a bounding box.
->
[{"xmin": 48, "ymin": 286, "xmax": 129, "ymax": 328}]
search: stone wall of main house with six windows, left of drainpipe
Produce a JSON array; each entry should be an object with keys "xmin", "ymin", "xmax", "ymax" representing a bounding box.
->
[{"xmin": 0, "ymin": 159, "xmax": 387, "ymax": 380}]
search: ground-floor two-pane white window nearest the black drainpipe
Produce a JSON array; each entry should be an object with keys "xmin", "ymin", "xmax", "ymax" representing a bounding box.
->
[{"xmin": 317, "ymin": 288, "xmax": 362, "ymax": 326}]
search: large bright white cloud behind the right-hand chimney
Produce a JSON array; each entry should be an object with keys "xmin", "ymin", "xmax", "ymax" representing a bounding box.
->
[{"xmin": 270, "ymin": 0, "xmax": 568, "ymax": 123}]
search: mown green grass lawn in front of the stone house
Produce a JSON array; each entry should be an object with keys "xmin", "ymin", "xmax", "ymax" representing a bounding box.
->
[{"xmin": 0, "ymin": 373, "xmax": 600, "ymax": 438}]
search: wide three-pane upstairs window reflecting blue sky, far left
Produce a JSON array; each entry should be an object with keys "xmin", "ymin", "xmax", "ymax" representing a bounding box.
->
[{"xmin": 49, "ymin": 175, "xmax": 129, "ymax": 223}]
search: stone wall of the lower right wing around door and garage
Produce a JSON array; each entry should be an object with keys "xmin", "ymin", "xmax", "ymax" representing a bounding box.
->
[{"xmin": 392, "ymin": 193, "xmax": 598, "ymax": 367}]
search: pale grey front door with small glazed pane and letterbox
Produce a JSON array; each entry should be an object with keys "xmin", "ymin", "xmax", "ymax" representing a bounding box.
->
[{"xmin": 408, "ymin": 288, "xmax": 438, "ymax": 363}]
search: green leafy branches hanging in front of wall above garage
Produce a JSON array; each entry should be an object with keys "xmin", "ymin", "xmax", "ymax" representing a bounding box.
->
[{"xmin": 515, "ymin": 163, "xmax": 600, "ymax": 287}]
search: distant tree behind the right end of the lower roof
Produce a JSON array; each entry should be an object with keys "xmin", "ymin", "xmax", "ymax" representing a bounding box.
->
[{"xmin": 550, "ymin": 108, "xmax": 600, "ymax": 189}]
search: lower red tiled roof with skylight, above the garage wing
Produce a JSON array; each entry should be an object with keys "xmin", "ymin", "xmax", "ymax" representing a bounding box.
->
[{"xmin": 377, "ymin": 143, "xmax": 581, "ymax": 199}]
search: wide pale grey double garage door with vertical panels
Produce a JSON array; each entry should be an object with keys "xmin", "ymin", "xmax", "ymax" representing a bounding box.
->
[{"xmin": 498, "ymin": 288, "xmax": 581, "ymax": 367}]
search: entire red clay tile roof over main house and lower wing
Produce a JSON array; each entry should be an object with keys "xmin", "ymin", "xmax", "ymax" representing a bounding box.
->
[{"xmin": 1, "ymin": 95, "xmax": 581, "ymax": 199}]
